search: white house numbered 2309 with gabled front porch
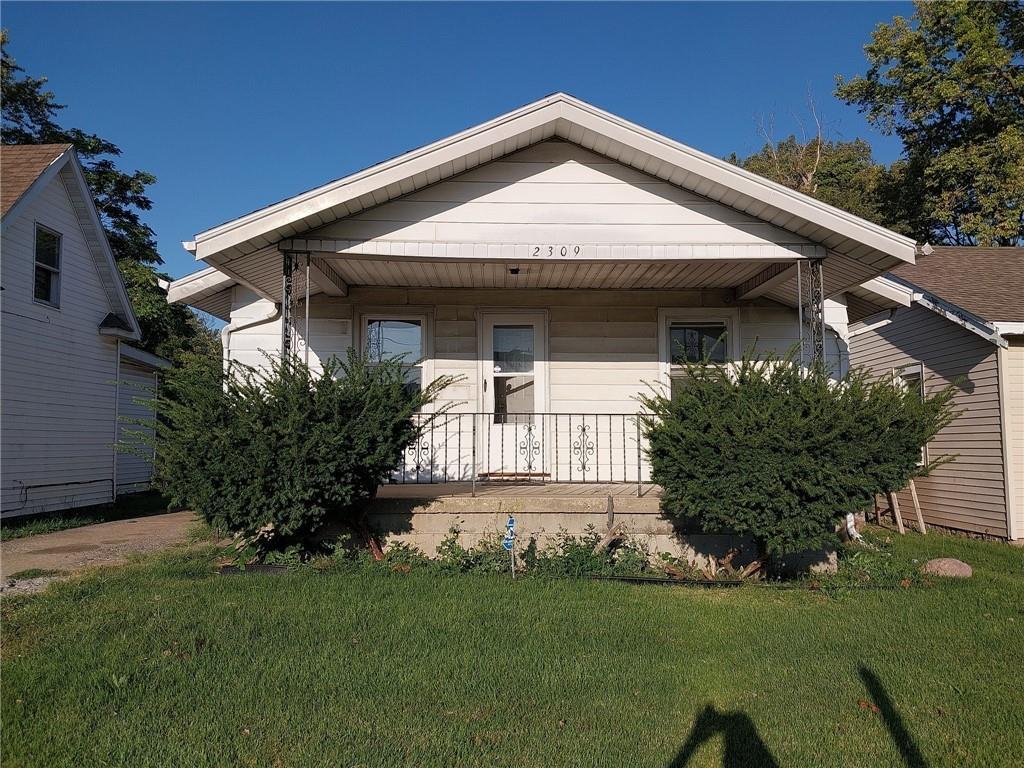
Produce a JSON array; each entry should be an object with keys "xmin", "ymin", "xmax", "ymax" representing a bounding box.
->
[{"xmin": 168, "ymin": 93, "xmax": 915, "ymax": 514}]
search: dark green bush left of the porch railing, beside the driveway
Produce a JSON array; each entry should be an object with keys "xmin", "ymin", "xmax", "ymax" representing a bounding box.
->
[{"xmin": 153, "ymin": 352, "xmax": 451, "ymax": 548}]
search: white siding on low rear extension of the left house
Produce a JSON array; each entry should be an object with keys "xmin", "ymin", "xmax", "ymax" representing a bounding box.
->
[{"xmin": 117, "ymin": 360, "xmax": 157, "ymax": 494}]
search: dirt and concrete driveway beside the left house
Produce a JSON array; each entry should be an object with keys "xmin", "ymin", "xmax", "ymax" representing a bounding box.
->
[{"xmin": 0, "ymin": 512, "xmax": 196, "ymax": 594}]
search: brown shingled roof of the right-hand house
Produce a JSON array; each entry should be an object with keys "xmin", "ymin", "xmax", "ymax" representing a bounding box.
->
[{"xmin": 892, "ymin": 246, "xmax": 1024, "ymax": 323}]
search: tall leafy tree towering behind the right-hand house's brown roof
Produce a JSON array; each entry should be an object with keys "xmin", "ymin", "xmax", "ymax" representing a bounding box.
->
[{"xmin": 836, "ymin": 0, "xmax": 1024, "ymax": 245}]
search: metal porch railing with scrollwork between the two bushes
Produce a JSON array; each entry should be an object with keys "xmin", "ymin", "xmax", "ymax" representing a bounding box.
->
[{"xmin": 390, "ymin": 412, "xmax": 650, "ymax": 493}]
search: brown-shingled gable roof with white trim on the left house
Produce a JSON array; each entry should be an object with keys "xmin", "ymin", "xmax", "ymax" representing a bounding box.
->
[{"xmin": 0, "ymin": 144, "xmax": 142, "ymax": 341}]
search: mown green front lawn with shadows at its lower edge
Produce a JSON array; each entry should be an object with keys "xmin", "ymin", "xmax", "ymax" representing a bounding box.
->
[{"xmin": 0, "ymin": 535, "xmax": 1024, "ymax": 768}]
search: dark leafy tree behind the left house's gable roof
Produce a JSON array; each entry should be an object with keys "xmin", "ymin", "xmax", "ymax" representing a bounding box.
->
[{"xmin": 0, "ymin": 30, "xmax": 219, "ymax": 358}]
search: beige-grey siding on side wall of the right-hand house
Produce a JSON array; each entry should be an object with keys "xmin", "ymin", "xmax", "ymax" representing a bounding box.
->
[{"xmin": 850, "ymin": 306, "xmax": 1007, "ymax": 537}]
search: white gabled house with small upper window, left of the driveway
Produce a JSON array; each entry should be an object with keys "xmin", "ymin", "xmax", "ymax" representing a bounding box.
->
[{"xmin": 0, "ymin": 144, "xmax": 167, "ymax": 516}]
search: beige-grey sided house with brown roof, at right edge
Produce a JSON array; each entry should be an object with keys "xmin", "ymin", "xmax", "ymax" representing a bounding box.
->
[{"xmin": 849, "ymin": 248, "xmax": 1024, "ymax": 539}]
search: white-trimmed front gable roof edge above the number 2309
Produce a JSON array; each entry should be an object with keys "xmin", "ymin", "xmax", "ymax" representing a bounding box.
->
[{"xmin": 184, "ymin": 93, "xmax": 915, "ymax": 282}]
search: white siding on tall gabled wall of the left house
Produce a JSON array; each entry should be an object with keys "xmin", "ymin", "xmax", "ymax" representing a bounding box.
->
[{"xmin": 0, "ymin": 169, "xmax": 117, "ymax": 515}]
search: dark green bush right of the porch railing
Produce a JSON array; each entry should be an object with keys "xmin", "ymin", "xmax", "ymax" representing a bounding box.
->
[{"xmin": 641, "ymin": 353, "xmax": 954, "ymax": 556}]
